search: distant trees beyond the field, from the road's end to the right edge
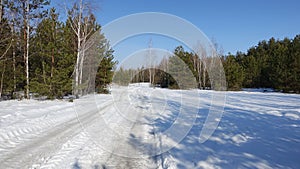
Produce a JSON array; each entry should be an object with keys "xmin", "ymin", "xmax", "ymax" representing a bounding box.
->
[{"xmin": 113, "ymin": 35, "xmax": 300, "ymax": 93}]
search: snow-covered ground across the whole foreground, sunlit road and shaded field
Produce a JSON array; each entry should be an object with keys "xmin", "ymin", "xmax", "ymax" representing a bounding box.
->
[{"xmin": 0, "ymin": 85, "xmax": 300, "ymax": 169}]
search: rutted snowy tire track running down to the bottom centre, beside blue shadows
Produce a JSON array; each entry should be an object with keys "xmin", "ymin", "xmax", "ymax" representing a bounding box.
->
[{"xmin": 102, "ymin": 90, "xmax": 157, "ymax": 168}]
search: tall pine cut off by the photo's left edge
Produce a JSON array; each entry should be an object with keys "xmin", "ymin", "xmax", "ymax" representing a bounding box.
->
[{"xmin": 0, "ymin": 0, "xmax": 23, "ymax": 97}]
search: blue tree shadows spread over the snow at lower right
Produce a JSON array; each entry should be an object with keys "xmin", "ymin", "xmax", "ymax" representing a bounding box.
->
[{"xmin": 129, "ymin": 93, "xmax": 300, "ymax": 168}]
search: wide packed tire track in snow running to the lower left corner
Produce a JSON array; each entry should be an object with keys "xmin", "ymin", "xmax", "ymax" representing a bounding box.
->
[{"xmin": 0, "ymin": 100, "xmax": 112, "ymax": 168}]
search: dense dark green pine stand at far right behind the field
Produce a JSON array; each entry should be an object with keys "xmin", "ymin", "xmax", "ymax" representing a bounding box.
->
[{"xmin": 223, "ymin": 35, "xmax": 300, "ymax": 93}]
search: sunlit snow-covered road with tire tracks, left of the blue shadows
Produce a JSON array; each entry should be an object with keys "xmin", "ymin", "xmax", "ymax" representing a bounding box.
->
[{"xmin": 0, "ymin": 86, "xmax": 157, "ymax": 168}]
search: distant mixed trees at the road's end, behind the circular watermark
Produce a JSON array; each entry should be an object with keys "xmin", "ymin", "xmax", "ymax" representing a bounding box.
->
[{"xmin": 113, "ymin": 46, "xmax": 226, "ymax": 89}]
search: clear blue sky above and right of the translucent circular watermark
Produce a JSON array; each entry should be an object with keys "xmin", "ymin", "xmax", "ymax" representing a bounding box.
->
[{"xmin": 54, "ymin": 0, "xmax": 300, "ymax": 57}]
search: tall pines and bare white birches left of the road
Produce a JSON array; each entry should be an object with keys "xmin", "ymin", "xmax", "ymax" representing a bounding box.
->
[{"xmin": 0, "ymin": 0, "xmax": 116, "ymax": 98}]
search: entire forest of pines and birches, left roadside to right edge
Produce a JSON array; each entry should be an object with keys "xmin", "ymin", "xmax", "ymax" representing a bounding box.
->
[{"xmin": 0, "ymin": 0, "xmax": 300, "ymax": 99}]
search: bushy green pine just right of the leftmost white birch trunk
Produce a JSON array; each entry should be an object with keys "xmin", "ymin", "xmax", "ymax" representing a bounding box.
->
[{"xmin": 30, "ymin": 8, "xmax": 68, "ymax": 98}]
